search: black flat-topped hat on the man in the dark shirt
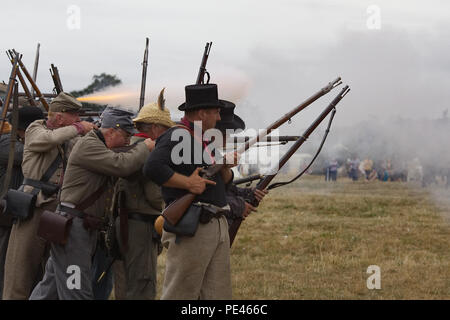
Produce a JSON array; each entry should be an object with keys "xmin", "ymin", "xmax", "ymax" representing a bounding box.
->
[{"xmin": 178, "ymin": 83, "xmax": 224, "ymax": 111}]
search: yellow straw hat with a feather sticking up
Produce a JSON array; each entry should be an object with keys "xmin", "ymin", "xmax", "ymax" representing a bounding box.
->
[{"xmin": 133, "ymin": 88, "xmax": 175, "ymax": 128}]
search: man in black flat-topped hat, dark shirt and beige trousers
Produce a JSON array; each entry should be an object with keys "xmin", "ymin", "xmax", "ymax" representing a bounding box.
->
[{"xmin": 144, "ymin": 84, "xmax": 237, "ymax": 300}]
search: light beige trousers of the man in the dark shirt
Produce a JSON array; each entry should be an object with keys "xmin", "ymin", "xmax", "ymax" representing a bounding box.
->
[{"xmin": 161, "ymin": 216, "xmax": 231, "ymax": 300}]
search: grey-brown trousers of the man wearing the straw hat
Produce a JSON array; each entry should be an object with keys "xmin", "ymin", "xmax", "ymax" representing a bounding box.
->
[{"xmin": 114, "ymin": 219, "xmax": 158, "ymax": 300}]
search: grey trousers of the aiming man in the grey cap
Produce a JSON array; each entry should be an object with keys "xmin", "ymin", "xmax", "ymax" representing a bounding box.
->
[{"xmin": 30, "ymin": 217, "xmax": 97, "ymax": 300}]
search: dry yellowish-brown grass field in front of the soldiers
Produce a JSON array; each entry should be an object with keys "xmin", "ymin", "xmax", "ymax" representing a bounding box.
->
[{"xmin": 158, "ymin": 177, "xmax": 450, "ymax": 299}]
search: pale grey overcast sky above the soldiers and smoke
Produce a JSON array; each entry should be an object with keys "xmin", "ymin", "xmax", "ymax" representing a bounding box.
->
[{"xmin": 0, "ymin": 0, "xmax": 450, "ymax": 131}]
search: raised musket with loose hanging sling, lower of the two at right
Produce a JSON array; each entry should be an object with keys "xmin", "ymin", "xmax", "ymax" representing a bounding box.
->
[{"xmin": 228, "ymin": 86, "xmax": 350, "ymax": 246}]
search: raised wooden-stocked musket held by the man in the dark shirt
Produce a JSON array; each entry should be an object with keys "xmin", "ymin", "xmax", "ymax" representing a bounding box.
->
[{"xmin": 162, "ymin": 77, "xmax": 342, "ymax": 225}]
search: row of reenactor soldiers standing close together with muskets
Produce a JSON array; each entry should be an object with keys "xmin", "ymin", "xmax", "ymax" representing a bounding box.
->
[{"xmin": 0, "ymin": 84, "xmax": 267, "ymax": 300}]
